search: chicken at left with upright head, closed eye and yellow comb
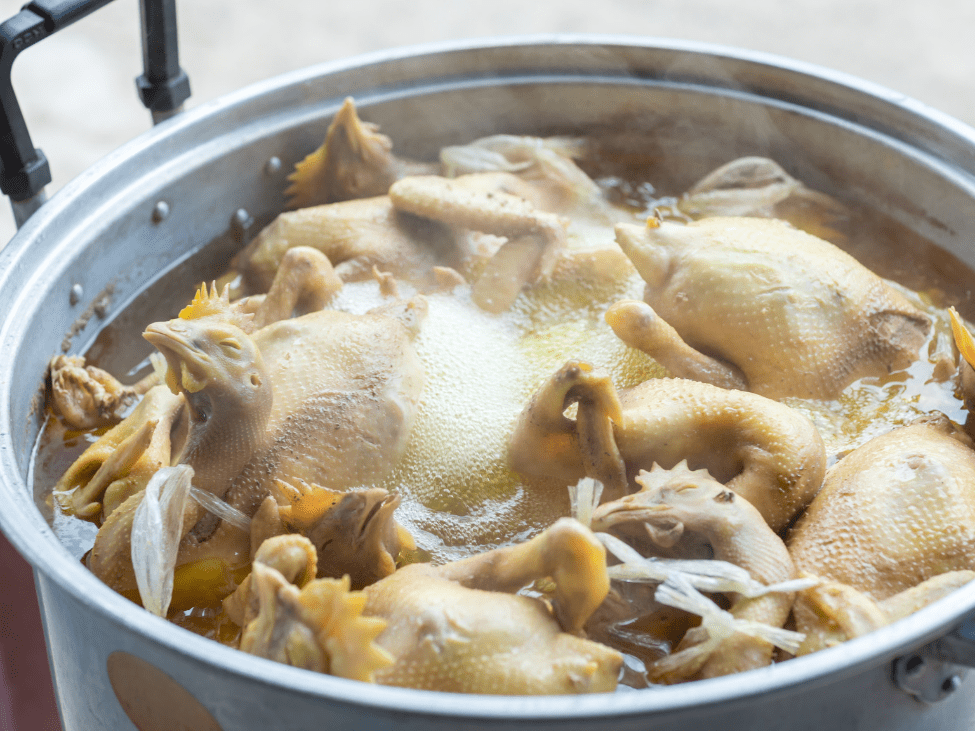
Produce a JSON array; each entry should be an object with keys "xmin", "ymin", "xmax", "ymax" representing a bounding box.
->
[{"xmin": 74, "ymin": 284, "xmax": 425, "ymax": 593}]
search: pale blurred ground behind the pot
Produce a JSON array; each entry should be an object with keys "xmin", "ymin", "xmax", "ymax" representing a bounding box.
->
[{"xmin": 0, "ymin": 0, "xmax": 975, "ymax": 243}]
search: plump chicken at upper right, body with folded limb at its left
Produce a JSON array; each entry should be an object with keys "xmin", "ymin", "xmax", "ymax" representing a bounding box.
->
[{"xmin": 606, "ymin": 218, "xmax": 931, "ymax": 399}]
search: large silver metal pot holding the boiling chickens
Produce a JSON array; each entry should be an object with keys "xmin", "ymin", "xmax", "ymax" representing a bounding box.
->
[{"xmin": 0, "ymin": 36, "xmax": 975, "ymax": 731}]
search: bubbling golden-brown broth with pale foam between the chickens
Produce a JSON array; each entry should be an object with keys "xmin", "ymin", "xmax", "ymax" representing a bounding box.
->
[{"xmin": 26, "ymin": 139, "xmax": 975, "ymax": 685}]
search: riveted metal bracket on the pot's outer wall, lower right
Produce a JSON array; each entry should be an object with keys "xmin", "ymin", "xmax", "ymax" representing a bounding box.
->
[{"xmin": 894, "ymin": 619, "xmax": 975, "ymax": 703}]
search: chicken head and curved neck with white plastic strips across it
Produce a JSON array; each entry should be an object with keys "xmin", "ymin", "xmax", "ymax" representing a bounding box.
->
[{"xmin": 592, "ymin": 465, "xmax": 796, "ymax": 683}]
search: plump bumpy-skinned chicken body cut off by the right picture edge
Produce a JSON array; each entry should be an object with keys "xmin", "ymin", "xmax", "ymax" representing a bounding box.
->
[{"xmin": 788, "ymin": 415, "xmax": 975, "ymax": 601}]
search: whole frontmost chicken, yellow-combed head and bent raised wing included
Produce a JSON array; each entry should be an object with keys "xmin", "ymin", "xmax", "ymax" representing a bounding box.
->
[{"xmin": 233, "ymin": 519, "xmax": 622, "ymax": 695}]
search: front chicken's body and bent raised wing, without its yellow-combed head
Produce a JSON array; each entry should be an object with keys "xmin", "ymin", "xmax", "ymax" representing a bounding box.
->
[{"xmin": 364, "ymin": 519, "xmax": 621, "ymax": 695}]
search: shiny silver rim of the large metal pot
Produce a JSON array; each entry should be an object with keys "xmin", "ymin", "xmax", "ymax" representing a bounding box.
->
[{"xmin": 0, "ymin": 34, "xmax": 975, "ymax": 721}]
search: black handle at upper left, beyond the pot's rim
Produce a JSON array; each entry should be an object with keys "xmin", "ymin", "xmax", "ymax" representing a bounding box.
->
[{"xmin": 0, "ymin": 0, "xmax": 190, "ymax": 228}]
